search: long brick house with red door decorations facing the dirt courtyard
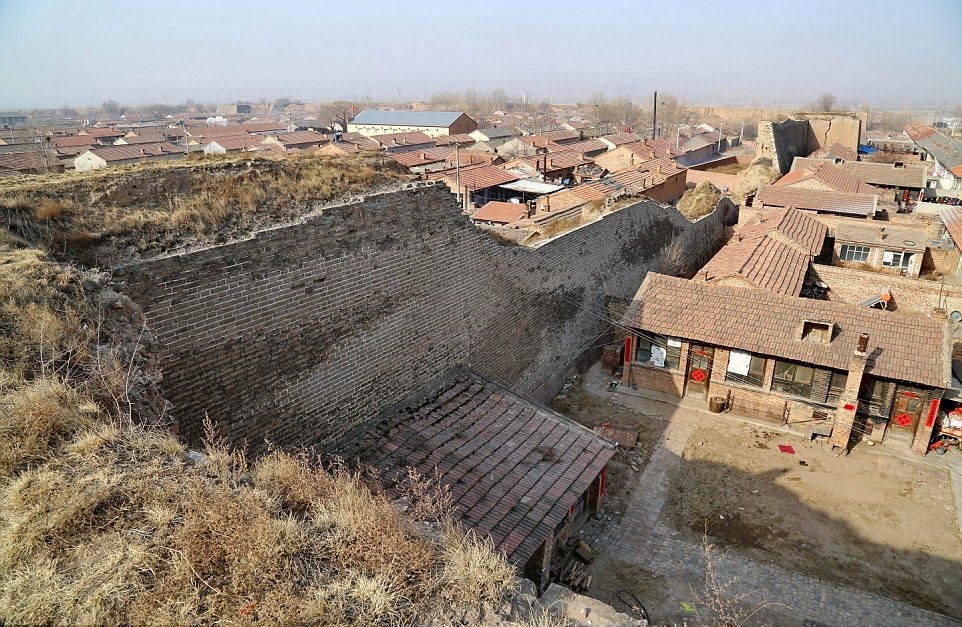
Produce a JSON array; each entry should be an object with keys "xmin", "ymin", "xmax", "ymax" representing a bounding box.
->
[{"xmin": 624, "ymin": 273, "xmax": 951, "ymax": 454}]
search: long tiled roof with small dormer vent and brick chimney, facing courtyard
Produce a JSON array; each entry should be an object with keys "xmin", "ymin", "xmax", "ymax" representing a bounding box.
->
[{"xmin": 625, "ymin": 273, "xmax": 951, "ymax": 388}]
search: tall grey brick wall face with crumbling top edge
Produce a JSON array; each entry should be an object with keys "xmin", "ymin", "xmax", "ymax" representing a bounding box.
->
[{"xmin": 114, "ymin": 184, "xmax": 736, "ymax": 451}]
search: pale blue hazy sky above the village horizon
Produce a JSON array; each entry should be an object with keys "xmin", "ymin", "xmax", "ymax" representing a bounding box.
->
[{"xmin": 0, "ymin": 0, "xmax": 962, "ymax": 108}]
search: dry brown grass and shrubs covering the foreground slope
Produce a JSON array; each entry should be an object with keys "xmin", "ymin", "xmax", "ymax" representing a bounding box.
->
[{"xmin": 0, "ymin": 241, "xmax": 532, "ymax": 626}]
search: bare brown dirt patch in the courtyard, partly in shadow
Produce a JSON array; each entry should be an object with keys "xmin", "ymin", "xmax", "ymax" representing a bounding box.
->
[{"xmin": 662, "ymin": 417, "xmax": 962, "ymax": 617}]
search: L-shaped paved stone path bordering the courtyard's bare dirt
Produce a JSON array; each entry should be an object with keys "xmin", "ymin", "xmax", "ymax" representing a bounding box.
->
[{"xmin": 610, "ymin": 388, "xmax": 962, "ymax": 627}]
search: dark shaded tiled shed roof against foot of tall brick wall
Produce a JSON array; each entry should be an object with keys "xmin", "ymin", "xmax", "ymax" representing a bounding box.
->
[{"xmin": 334, "ymin": 371, "xmax": 614, "ymax": 566}]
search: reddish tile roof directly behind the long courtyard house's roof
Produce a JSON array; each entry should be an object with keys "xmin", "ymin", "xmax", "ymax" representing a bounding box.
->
[{"xmin": 696, "ymin": 235, "xmax": 810, "ymax": 296}]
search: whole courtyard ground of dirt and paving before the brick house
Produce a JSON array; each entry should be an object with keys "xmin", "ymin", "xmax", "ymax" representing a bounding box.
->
[{"xmin": 552, "ymin": 365, "xmax": 962, "ymax": 626}]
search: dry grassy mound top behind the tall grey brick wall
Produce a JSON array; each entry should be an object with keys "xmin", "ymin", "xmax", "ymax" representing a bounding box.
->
[{"xmin": 0, "ymin": 154, "xmax": 407, "ymax": 265}]
